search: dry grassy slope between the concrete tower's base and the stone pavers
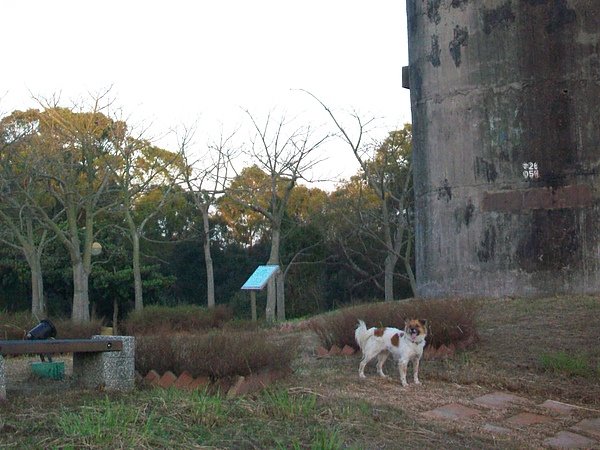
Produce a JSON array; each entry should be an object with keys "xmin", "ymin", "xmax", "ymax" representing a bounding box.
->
[{"xmin": 429, "ymin": 296, "xmax": 600, "ymax": 407}]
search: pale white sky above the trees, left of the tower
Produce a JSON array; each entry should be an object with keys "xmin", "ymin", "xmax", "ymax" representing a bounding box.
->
[{"xmin": 0, "ymin": 0, "xmax": 411, "ymax": 188}]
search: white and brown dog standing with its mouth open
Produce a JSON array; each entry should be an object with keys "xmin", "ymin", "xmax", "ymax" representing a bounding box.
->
[{"xmin": 354, "ymin": 319, "xmax": 427, "ymax": 386}]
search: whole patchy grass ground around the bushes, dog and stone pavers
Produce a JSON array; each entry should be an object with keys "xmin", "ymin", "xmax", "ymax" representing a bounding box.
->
[{"xmin": 0, "ymin": 296, "xmax": 600, "ymax": 449}]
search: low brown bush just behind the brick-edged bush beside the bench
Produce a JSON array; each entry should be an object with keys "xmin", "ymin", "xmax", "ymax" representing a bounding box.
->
[{"xmin": 121, "ymin": 305, "xmax": 233, "ymax": 336}]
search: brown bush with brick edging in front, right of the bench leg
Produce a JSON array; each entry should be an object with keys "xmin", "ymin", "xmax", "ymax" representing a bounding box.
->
[{"xmin": 135, "ymin": 330, "xmax": 297, "ymax": 379}]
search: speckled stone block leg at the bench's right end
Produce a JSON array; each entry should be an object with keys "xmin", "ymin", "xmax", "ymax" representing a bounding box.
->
[{"xmin": 73, "ymin": 336, "xmax": 135, "ymax": 391}]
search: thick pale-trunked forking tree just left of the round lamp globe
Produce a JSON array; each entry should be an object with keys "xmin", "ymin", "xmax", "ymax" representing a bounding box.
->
[{"xmin": 2, "ymin": 103, "xmax": 123, "ymax": 322}]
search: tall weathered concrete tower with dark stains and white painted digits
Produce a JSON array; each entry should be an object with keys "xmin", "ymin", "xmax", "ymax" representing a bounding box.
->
[{"xmin": 407, "ymin": 0, "xmax": 600, "ymax": 297}]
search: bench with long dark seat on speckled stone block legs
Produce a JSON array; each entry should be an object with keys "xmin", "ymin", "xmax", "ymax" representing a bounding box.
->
[{"xmin": 0, "ymin": 336, "xmax": 135, "ymax": 400}]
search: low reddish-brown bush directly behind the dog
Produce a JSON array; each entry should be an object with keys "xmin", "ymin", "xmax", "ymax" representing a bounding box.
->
[{"xmin": 309, "ymin": 299, "xmax": 479, "ymax": 349}]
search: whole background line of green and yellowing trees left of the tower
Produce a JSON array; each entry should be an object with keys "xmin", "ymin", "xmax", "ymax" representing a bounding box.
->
[{"xmin": 0, "ymin": 98, "xmax": 413, "ymax": 322}]
